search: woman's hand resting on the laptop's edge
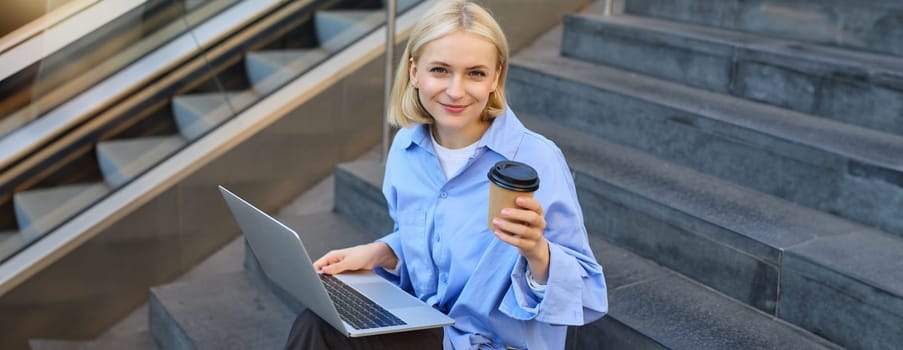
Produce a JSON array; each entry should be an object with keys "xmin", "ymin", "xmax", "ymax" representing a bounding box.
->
[{"xmin": 314, "ymin": 242, "xmax": 398, "ymax": 275}]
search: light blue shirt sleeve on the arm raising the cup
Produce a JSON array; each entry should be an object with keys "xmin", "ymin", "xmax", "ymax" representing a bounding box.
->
[{"xmin": 499, "ymin": 142, "xmax": 608, "ymax": 325}]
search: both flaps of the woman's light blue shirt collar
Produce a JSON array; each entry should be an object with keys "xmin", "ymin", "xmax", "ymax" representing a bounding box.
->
[{"xmin": 402, "ymin": 106, "xmax": 526, "ymax": 160}]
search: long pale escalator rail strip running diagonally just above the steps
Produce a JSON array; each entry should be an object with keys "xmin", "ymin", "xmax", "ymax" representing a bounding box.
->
[{"xmin": 0, "ymin": 0, "xmax": 281, "ymax": 173}]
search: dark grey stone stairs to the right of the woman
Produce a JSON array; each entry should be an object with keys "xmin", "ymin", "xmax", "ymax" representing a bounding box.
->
[{"xmin": 508, "ymin": 0, "xmax": 903, "ymax": 349}]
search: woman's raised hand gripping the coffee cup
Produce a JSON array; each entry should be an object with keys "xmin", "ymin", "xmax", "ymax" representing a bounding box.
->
[{"xmin": 492, "ymin": 196, "xmax": 549, "ymax": 284}]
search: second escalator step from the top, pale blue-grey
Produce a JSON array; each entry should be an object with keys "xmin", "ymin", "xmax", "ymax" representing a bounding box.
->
[{"xmin": 245, "ymin": 48, "xmax": 328, "ymax": 95}]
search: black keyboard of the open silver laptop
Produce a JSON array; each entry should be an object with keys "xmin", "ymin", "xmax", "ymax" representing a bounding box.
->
[{"xmin": 320, "ymin": 273, "xmax": 406, "ymax": 329}]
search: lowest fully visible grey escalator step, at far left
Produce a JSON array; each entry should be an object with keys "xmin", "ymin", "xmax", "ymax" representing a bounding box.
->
[{"xmin": 13, "ymin": 182, "xmax": 110, "ymax": 240}]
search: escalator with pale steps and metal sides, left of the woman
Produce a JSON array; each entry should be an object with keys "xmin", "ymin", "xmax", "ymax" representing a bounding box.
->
[{"xmin": 0, "ymin": 0, "xmax": 420, "ymax": 348}]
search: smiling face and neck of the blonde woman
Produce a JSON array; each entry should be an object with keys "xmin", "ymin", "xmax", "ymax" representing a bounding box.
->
[{"xmin": 410, "ymin": 32, "xmax": 500, "ymax": 146}]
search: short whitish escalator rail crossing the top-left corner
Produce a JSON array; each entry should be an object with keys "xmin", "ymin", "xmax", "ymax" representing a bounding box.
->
[{"xmin": 0, "ymin": 0, "xmax": 147, "ymax": 81}]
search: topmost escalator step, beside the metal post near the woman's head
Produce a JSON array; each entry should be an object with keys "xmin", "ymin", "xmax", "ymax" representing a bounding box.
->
[{"xmin": 314, "ymin": 10, "xmax": 386, "ymax": 52}]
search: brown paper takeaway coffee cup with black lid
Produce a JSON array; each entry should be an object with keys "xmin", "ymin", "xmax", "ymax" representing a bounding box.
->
[{"xmin": 488, "ymin": 160, "xmax": 539, "ymax": 231}]
